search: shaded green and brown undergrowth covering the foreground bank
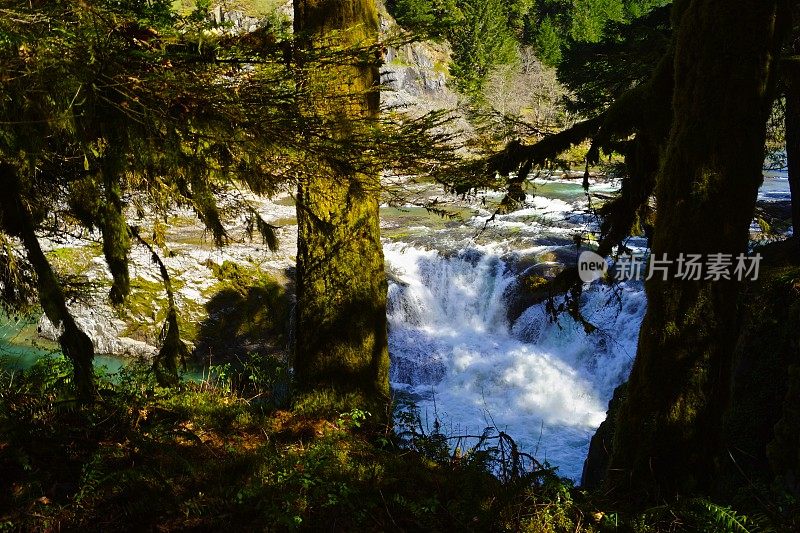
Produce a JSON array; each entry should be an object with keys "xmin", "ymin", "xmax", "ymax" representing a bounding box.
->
[{"xmin": 0, "ymin": 357, "xmax": 792, "ymax": 532}]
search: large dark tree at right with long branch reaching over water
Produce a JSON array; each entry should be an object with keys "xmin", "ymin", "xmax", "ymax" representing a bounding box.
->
[{"xmin": 476, "ymin": 0, "xmax": 789, "ymax": 501}]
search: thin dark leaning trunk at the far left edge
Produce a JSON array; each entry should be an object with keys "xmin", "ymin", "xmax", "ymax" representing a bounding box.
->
[{"xmin": 0, "ymin": 164, "xmax": 96, "ymax": 403}]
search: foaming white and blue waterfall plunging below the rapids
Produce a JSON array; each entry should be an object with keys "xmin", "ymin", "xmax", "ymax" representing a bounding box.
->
[{"xmin": 384, "ymin": 243, "xmax": 645, "ymax": 479}]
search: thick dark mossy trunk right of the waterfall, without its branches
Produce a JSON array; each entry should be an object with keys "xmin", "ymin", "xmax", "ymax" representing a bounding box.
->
[{"xmin": 608, "ymin": 0, "xmax": 782, "ymax": 500}]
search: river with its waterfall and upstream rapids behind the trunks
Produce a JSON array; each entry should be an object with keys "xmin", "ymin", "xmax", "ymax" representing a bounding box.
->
[{"xmin": 0, "ymin": 172, "xmax": 789, "ymax": 481}]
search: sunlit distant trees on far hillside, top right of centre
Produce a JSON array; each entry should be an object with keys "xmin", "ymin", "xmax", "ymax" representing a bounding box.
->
[{"xmin": 389, "ymin": 0, "xmax": 670, "ymax": 140}]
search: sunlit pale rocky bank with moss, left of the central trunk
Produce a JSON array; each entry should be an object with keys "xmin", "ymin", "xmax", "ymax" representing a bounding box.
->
[{"xmin": 39, "ymin": 193, "xmax": 297, "ymax": 357}]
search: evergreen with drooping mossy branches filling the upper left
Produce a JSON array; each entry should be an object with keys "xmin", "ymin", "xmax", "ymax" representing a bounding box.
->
[{"xmin": 0, "ymin": 1, "xmax": 296, "ymax": 390}]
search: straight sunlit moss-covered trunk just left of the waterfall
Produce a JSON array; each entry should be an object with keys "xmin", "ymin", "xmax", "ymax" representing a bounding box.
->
[{"xmin": 294, "ymin": 0, "xmax": 389, "ymax": 415}]
